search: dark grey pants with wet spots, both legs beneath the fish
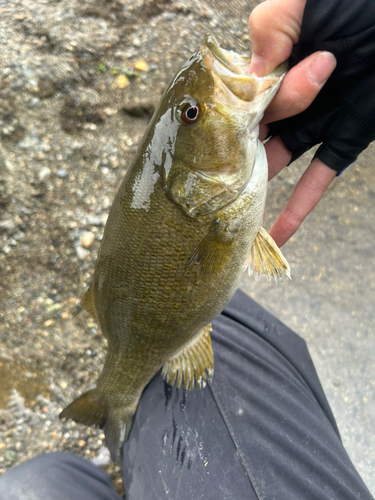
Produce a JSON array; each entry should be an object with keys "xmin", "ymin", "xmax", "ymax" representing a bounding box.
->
[{"xmin": 0, "ymin": 292, "xmax": 373, "ymax": 500}]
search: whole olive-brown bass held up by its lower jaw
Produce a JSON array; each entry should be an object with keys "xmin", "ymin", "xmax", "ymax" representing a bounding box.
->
[{"xmin": 60, "ymin": 34, "xmax": 290, "ymax": 461}]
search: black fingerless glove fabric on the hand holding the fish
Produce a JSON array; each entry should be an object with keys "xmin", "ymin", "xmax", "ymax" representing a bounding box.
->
[{"xmin": 269, "ymin": 0, "xmax": 375, "ymax": 173}]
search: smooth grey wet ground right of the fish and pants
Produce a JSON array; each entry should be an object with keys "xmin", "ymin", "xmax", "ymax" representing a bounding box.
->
[{"xmin": 241, "ymin": 145, "xmax": 375, "ymax": 493}]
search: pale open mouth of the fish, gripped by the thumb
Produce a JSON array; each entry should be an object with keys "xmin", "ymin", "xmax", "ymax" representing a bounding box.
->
[{"xmin": 201, "ymin": 34, "xmax": 288, "ymax": 113}]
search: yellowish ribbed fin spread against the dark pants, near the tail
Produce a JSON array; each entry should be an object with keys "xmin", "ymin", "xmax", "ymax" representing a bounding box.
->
[{"xmin": 162, "ymin": 325, "xmax": 214, "ymax": 389}]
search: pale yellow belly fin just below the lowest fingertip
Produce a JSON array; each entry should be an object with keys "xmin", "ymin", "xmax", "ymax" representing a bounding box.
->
[{"xmin": 247, "ymin": 227, "xmax": 291, "ymax": 283}]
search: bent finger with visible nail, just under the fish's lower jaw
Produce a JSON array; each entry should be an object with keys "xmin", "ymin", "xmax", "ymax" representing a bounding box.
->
[{"xmin": 261, "ymin": 52, "xmax": 336, "ymax": 124}]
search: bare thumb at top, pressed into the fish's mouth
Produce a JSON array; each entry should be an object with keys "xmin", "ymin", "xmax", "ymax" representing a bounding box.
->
[{"xmin": 249, "ymin": 0, "xmax": 306, "ymax": 76}]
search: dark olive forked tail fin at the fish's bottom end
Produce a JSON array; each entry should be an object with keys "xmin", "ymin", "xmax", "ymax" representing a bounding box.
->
[{"xmin": 59, "ymin": 389, "xmax": 135, "ymax": 462}]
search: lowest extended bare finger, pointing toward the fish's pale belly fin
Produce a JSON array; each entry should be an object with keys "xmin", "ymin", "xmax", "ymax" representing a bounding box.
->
[{"xmin": 269, "ymin": 158, "xmax": 337, "ymax": 247}]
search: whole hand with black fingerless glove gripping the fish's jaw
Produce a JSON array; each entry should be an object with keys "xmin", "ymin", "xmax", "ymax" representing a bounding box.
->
[{"xmin": 250, "ymin": 0, "xmax": 375, "ymax": 246}]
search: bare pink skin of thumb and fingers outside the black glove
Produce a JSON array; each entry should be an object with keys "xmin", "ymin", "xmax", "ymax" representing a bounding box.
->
[{"xmin": 249, "ymin": 0, "xmax": 336, "ymax": 247}]
